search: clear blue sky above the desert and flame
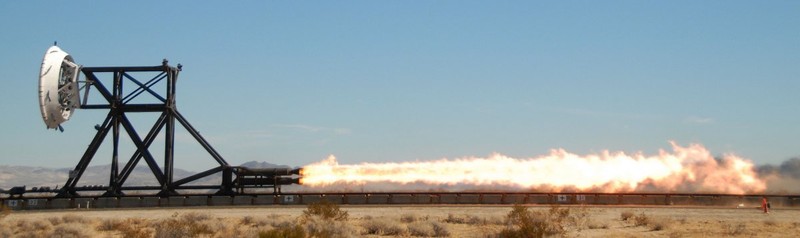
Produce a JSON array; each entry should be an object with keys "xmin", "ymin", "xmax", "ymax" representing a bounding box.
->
[{"xmin": 0, "ymin": 1, "xmax": 800, "ymax": 170}]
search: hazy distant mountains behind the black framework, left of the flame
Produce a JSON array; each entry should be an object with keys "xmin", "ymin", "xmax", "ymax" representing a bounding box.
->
[{"xmin": 0, "ymin": 161, "xmax": 289, "ymax": 189}]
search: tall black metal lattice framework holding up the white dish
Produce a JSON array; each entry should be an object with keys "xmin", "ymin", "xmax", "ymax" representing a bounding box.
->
[{"xmin": 57, "ymin": 60, "xmax": 236, "ymax": 197}]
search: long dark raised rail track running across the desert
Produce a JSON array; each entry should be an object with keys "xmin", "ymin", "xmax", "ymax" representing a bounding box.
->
[{"xmin": 0, "ymin": 192, "xmax": 800, "ymax": 210}]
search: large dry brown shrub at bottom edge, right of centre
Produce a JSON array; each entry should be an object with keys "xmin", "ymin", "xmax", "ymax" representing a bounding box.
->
[{"xmin": 497, "ymin": 205, "xmax": 570, "ymax": 237}]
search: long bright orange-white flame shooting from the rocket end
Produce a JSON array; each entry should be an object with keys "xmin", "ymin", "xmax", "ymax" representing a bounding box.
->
[{"xmin": 301, "ymin": 142, "xmax": 766, "ymax": 194}]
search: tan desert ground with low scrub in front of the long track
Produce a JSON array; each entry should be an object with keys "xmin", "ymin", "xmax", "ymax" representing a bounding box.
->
[{"xmin": 0, "ymin": 205, "xmax": 800, "ymax": 237}]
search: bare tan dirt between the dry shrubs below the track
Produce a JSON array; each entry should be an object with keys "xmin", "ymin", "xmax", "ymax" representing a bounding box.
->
[{"xmin": 0, "ymin": 205, "xmax": 800, "ymax": 237}]
